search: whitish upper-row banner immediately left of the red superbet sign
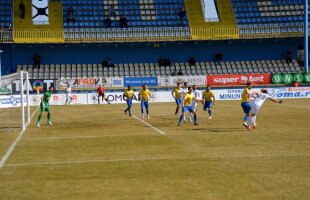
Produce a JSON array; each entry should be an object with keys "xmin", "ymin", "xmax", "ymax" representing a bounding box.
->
[{"xmin": 160, "ymin": 76, "xmax": 206, "ymax": 87}]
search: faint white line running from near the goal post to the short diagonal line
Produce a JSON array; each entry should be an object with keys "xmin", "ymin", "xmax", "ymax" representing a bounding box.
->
[{"xmin": 22, "ymin": 134, "xmax": 157, "ymax": 141}]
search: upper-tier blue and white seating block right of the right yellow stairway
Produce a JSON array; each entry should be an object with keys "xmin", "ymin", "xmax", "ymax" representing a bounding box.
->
[{"xmin": 231, "ymin": 0, "xmax": 304, "ymax": 25}]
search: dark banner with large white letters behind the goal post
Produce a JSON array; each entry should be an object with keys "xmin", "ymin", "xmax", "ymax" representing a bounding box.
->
[{"xmin": 12, "ymin": 79, "xmax": 58, "ymax": 93}]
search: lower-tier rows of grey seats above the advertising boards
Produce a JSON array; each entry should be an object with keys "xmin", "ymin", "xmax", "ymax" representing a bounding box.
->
[{"xmin": 17, "ymin": 60, "xmax": 302, "ymax": 79}]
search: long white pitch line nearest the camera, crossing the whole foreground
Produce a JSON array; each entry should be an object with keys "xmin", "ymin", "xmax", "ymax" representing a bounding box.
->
[{"xmin": 4, "ymin": 153, "xmax": 310, "ymax": 167}]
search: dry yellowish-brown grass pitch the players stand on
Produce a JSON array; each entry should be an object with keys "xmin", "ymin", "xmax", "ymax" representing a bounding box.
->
[{"xmin": 0, "ymin": 99, "xmax": 310, "ymax": 200}]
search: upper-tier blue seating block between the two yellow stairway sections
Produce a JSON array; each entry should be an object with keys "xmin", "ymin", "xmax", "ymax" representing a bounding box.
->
[{"xmin": 62, "ymin": 0, "xmax": 188, "ymax": 29}]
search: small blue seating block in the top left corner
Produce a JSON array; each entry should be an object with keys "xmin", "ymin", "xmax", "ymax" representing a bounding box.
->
[{"xmin": 0, "ymin": 0, "xmax": 12, "ymax": 29}]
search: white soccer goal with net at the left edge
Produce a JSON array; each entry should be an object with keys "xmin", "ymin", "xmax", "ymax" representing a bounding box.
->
[{"xmin": 0, "ymin": 71, "xmax": 30, "ymax": 131}]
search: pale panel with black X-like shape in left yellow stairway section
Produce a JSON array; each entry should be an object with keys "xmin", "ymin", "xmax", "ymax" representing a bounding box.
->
[{"xmin": 32, "ymin": 0, "xmax": 49, "ymax": 25}]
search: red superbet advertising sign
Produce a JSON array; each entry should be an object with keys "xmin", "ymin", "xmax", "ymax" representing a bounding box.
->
[{"xmin": 207, "ymin": 74, "xmax": 271, "ymax": 86}]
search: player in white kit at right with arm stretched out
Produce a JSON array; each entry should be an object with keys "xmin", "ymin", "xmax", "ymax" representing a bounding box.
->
[{"xmin": 246, "ymin": 89, "xmax": 282, "ymax": 130}]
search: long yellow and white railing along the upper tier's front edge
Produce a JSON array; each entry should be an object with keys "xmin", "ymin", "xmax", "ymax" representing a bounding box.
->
[{"xmin": 0, "ymin": 24, "xmax": 303, "ymax": 43}]
